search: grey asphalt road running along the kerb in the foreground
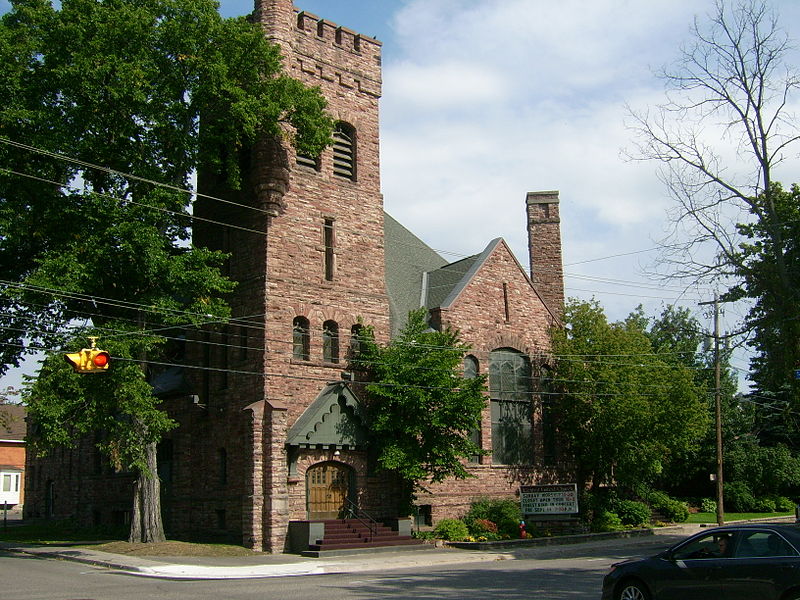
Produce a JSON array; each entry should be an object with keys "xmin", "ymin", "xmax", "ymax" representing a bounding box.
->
[{"xmin": 0, "ymin": 536, "xmax": 680, "ymax": 600}]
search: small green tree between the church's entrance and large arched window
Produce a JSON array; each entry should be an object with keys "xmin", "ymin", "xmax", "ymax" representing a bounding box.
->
[{"xmin": 351, "ymin": 309, "xmax": 486, "ymax": 508}]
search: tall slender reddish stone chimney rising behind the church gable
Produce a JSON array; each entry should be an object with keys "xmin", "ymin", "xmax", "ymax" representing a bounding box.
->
[{"xmin": 526, "ymin": 191, "xmax": 564, "ymax": 318}]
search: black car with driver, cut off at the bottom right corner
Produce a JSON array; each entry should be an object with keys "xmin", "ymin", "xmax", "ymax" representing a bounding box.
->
[{"xmin": 603, "ymin": 523, "xmax": 800, "ymax": 600}]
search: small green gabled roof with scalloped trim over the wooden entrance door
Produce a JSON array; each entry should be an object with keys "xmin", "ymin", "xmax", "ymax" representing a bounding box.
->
[{"xmin": 286, "ymin": 382, "xmax": 367, "ymax": 448}]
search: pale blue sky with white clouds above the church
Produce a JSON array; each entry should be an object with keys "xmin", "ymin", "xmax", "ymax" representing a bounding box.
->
[{"xmin": 0, "ymin": 0, "xmax": 800, "ymax": 385}]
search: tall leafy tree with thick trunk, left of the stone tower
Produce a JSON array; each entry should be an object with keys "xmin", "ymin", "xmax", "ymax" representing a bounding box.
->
[{"xmin": 0, "ymin": 0, "xmax": 332, "ymax": 541}]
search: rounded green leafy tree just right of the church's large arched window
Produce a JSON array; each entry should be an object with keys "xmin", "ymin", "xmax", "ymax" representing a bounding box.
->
[{"xmin": 552, "ymin": 301, "xmax": 709, "ymax": 489}]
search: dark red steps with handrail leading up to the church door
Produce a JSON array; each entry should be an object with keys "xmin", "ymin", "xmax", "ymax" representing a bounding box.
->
[{"xmin": 302, "ymin": 519, "xmax": 433, "ymax": 557}]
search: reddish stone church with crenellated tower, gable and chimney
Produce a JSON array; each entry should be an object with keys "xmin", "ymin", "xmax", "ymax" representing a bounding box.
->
[{"xmin": 26, "ymin": 0, "xmax": 564, "ymax": 552}]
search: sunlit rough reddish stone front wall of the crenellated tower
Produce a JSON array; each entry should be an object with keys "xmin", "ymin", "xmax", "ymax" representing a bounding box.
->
[{"xmin": 260, "ymin": 2, "xmax": 389, "ymax": 551}]
